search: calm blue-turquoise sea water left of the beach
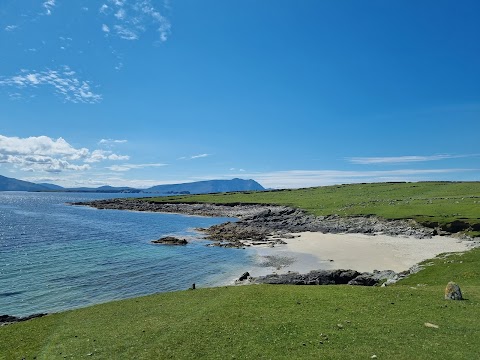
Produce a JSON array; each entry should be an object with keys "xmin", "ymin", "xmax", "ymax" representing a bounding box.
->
[{"xmin": 0, "ymin": 192, "xmax": 254, "ymax": 316}]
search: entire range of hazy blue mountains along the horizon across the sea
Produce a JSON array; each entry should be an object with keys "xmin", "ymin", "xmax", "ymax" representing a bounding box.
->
[{"xmin": 0, "ymin": 175, "xmax": 265, "ymax": 194}]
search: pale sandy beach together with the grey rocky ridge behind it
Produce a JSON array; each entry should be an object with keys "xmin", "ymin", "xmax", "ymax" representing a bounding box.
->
[{"xmin": 73, "ymin": 199, "xmax": 480, "ymax": 276}]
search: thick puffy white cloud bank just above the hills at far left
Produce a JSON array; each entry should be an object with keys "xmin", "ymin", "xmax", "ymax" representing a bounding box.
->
[{"xmin": 0, "ymin": 135, "xmax": 129, "ymax": 173}]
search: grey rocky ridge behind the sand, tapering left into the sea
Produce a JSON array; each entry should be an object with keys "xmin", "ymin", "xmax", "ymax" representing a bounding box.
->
[{"xmin": 73, "ymin": 199, "xmax": 436, "ymax": 248}]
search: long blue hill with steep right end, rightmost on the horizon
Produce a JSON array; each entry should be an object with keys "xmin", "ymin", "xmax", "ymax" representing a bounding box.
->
[{"xmin": 143, "ymin": 179, "xmax": 265, "ymax": 194}]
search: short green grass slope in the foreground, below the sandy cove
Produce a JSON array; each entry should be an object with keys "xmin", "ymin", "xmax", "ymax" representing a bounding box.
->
[{"xmin": 0, "ymin": 249, "xmax": 480, "ymax": 359}]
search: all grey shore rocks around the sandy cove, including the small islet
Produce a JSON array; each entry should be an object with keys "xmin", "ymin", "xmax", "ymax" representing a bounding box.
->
[{"xmin": 72, "ymin": 199, "xmax": 480, "ymax": 286}]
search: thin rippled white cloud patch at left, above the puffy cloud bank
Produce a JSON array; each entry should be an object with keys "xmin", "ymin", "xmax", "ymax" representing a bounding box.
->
[{"xmin": 0, "ymin": 66, "xmax": 102, "ymax": 104}]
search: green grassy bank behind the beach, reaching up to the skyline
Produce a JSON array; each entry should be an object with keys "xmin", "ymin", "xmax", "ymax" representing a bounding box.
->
[{"xmin": 146, "ymin": 182, "xmax": 480, "ymax": 236}]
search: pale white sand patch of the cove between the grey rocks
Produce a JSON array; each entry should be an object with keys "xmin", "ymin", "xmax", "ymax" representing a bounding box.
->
[{"xmin": 252, "ymin": 232, "xmax": 471, "ymax": 276}]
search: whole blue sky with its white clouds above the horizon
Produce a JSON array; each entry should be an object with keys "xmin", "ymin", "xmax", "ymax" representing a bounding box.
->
[{"xmin": 0, "ymin": 0, "xmax": 480, "ymax": 188}]
